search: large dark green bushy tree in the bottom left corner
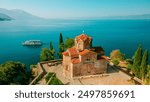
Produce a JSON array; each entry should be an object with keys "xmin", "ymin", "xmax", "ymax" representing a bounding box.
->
[{"xmin": 0, "ymin": 61, "xmax": 28, "ymax": 85}]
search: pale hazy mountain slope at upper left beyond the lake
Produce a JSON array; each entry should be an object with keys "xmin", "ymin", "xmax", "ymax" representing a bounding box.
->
[{"xmin": 0, "ymin": 8, "xmax": 43, "ymax": 20}]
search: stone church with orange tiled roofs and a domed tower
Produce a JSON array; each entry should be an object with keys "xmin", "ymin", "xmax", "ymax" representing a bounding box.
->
[{"xmin": 62, "ymin": 34, "xmax": 108, "ymax": 79}]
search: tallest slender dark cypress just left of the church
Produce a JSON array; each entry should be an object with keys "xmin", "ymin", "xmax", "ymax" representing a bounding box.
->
[{"xmin": 58, "ymin": 33, "xmax": 64, "ymax": 58}]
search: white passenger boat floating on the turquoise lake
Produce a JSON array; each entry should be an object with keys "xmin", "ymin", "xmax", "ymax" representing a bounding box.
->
[{"xmin": 22, "ymin": 40, "xmax": 43, "ymax": 46}]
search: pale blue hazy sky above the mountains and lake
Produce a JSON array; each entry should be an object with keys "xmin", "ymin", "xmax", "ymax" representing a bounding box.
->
[{"xmin": 0, "ymin": 0, "xmax": 150, "ymax": 18}]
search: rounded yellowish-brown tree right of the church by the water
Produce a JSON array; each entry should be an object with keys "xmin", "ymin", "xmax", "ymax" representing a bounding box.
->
[{"xmin": 110, "ymin": 50, "xmax": 125, "ymax": 61}]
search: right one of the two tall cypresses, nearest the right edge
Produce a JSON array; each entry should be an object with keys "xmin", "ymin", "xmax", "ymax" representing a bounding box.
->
[{"xmin": 140, "ymin": 50, "xmax": 148, "ymax": 79}]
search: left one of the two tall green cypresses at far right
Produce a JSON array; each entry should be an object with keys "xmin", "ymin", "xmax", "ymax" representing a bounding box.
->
[{"xmin": 132, "ymin": 45, "xmax": 142, "ymax": 78}]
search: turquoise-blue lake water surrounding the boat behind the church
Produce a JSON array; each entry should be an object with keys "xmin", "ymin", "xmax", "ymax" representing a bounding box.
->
[{"xmin": 0, "ymin": 20, "xmax": 150, "ymax": 65}]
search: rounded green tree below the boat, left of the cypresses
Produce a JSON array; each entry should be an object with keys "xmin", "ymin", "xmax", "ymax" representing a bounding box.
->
[{"xmin": 40, "ymin": 48, "xmax": 51, "ymax": 61}]
